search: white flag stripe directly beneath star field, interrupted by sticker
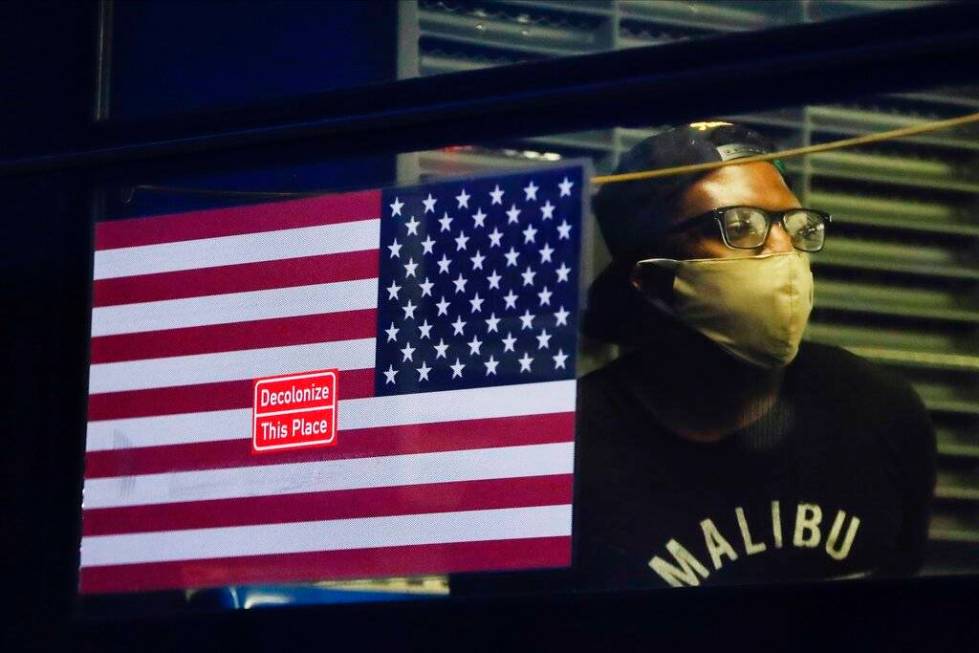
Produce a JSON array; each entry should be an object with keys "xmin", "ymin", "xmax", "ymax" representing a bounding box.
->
[{"xmin": 86, "ymin": 380, "xmax": 575, "ymax": 451}]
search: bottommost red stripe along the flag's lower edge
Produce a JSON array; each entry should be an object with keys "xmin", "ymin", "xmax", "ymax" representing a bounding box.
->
[{"xmin": 80, "ymin": 536, "xmax": 571, "ymax": 594}]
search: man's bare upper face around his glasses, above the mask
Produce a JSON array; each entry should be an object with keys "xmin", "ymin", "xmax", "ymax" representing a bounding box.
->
[{"xmin": 664, "ymin": 162, "xmax": 802, "ymax": 260}]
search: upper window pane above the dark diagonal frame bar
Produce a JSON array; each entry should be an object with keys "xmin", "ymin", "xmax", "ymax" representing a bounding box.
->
[{"xmin": 105, "ymin": 0, "xmax": 940, "ymax": 120}]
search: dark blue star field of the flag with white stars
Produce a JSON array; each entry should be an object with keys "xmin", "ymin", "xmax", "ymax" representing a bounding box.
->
[{"xmin": 375, "ymin": 168, "xmax": 582, "ymax": 395}]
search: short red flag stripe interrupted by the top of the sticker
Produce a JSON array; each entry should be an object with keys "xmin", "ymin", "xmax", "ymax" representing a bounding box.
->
[{"xmin": 88, "ymin": 370, "xmax": 374, "ymax": 421}]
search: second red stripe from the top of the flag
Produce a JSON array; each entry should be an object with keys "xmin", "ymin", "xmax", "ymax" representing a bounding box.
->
[{"xmin": 92, "ymin": 249, "xmax": 378, "ymax": 308}]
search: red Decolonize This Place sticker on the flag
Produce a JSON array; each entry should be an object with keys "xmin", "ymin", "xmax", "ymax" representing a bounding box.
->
[{"xmin": 252, "ymin": 370, "xmax": 340, "ymax": 453}]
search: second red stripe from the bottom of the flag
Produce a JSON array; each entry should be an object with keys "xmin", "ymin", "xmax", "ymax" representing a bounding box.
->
[{"xmin": 83, "ymin": 474, "xmax": 572, "ymax": 537}]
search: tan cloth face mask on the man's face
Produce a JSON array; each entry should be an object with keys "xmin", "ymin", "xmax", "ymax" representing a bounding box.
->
[{"xmin": 639, "ymin": 251, "xmax": 813, "ymax": 368}]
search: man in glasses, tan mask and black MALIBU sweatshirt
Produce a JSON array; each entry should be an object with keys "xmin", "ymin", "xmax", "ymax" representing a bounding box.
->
[{"xmin": 574, "ymin": 123, "xmax": 935, "ymax": 588}]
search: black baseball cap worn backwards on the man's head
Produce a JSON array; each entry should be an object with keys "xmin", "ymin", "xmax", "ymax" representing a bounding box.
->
[{"xmin": 592, "ymin": 122, "xmax": 785, "ymax": 262}]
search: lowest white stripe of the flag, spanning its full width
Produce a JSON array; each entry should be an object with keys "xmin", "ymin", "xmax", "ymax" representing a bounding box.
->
[{"xmin": 81, "ymin": 505, "xmax": 571, "ymax": 567}]
